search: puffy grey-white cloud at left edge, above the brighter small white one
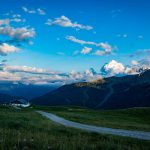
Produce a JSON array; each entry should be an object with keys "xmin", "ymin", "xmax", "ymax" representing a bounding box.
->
[{"xmin": 0, "ymin": 26, "xmax": 35, "ymax": 40}]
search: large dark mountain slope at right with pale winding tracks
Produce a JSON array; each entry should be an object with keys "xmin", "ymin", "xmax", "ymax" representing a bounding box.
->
[{"xmin": 32, "ymin": 70, "xmax": 150, "ymax": 109}]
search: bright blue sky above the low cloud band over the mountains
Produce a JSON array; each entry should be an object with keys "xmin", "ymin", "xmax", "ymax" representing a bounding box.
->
[{"xmin": 0, "ymin": 0, "xmax": 150, "ymax": 84}]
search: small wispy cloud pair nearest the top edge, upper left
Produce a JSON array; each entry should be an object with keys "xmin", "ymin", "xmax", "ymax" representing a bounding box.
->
[{"xmin": 22, "ymin": 7, "xmax": 46, "ymax": 15}]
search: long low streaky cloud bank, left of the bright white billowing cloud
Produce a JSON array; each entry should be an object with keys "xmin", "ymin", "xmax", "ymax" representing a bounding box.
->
[{"xmin": 0, "ymin": 60, "xmax": 101, "ymax": 85}]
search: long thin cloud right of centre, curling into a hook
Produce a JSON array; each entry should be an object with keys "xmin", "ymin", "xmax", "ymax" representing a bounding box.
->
[{"xmin": 66, "ymin": 36, "xmax": 114, "ymax": 56}]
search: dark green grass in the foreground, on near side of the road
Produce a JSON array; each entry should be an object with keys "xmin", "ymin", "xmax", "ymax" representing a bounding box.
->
[{"xmin": 0, "ymin": 107, "xmax": 150, "ymax": 150}]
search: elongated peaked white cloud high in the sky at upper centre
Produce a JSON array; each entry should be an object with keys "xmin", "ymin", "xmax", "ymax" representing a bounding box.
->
[{"xmin": 45, "ymin": 16, "xmax": 93, "ymax": 30}]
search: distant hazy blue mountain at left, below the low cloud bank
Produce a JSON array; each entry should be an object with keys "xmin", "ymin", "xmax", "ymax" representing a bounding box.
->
[{"xmin": 0, "ymin": 83, "xmax": 57, "ymax": 99}]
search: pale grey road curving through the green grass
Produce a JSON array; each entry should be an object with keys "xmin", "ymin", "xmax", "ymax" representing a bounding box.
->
[{"xmin": 36, "ymin": 111, "xmax": 150, "ymax": 140}]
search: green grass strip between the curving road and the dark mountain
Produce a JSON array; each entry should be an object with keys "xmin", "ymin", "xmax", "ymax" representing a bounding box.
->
[{"xmin": 35, "ymin": 106, "xmax": 150, "ymax": 131}]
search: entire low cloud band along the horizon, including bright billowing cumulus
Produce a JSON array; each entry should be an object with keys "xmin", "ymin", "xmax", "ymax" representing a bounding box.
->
[{"xmin": 0, "ymin": 60, "xmax": 150, "ymax": 85}]
